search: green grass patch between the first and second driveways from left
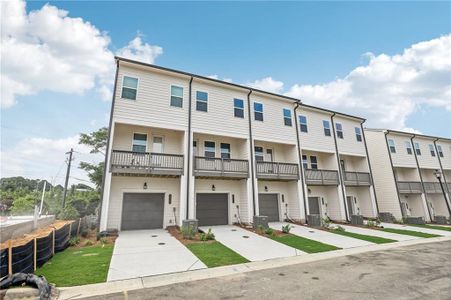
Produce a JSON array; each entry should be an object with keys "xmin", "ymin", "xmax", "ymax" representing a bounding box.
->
[{"xmin": 186, "ymin": 242, "xmax": 249, "ymax": 268}]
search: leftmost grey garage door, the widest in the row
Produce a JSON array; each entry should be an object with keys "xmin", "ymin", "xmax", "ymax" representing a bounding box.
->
[{"xmin": 121, "ymin": 193, "xmax": 164, "ymax": 230}]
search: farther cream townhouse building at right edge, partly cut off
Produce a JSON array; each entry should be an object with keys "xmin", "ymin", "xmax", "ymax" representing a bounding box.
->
[{"xmin": 365, "ymin": 129, "xmax": 451, "ymax": 222}]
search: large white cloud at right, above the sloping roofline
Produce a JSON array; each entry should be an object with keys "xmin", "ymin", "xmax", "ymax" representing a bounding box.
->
[{"xmin": 286, "ymin": 35, "xmax": 451, "ymax": 130}]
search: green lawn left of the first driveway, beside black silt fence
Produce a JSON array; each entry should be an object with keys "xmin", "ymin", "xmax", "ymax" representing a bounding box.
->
[{"xmin": 35, "ymin": 245, "xmax": 113, "ymax": 287}]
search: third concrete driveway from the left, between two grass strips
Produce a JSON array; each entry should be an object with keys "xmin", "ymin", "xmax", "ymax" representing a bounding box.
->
[{"xmin": 269, "ymin": 222, "xmax": 373, "ymax": 249}]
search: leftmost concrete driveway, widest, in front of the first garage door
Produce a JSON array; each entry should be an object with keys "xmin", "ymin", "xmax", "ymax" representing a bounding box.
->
[{"xmin": 107, "ymin": 229, "xmax": 206, "ymax": 281}]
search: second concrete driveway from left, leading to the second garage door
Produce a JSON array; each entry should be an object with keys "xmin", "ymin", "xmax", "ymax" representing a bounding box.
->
[{"xmin": 200, "ymin": 225, "xmax": 306, "ymax": 261}]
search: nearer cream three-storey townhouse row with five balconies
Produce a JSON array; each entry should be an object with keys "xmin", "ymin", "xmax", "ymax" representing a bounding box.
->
[{"xmin": 100, "ymin": 58, "xmax": 378, "ymax": 230}]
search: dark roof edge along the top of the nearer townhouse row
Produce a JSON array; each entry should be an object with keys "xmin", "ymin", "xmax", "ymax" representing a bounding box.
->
[{"xmin": 114, "ymin": 56, "xmax": 366, "ymax": 123}]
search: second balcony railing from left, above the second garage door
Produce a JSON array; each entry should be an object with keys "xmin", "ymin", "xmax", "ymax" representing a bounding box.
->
[{"xmin": 193, "ymin": 156, "xmax": 249, "ymax": 178}]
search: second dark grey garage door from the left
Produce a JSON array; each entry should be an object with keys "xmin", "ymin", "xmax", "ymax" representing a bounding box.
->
[{"xmin": 196, "ymin": 194, "xmax": 229, "ymax": 226}]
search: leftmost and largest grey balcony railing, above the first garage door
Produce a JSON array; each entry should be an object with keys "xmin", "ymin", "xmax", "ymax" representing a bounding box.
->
[{"xmin": 110, "ymin": 150, "xmax": 183, "ymax": 176}]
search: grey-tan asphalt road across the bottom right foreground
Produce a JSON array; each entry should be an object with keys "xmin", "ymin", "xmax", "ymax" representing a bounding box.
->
[{"xmin": 83, "ymin": 241, "xmax": 451, "ymax": 300}]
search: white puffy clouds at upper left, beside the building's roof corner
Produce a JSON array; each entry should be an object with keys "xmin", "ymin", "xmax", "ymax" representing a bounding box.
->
[{"xmin": 0, "ymin": 0, "xmax": 162, "ymax": 108}]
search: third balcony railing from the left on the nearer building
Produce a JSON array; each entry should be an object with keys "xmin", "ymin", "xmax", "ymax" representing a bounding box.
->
[{"xmin": 257, "ymin": 161, "xmax": 299, "ymax": 180}]
